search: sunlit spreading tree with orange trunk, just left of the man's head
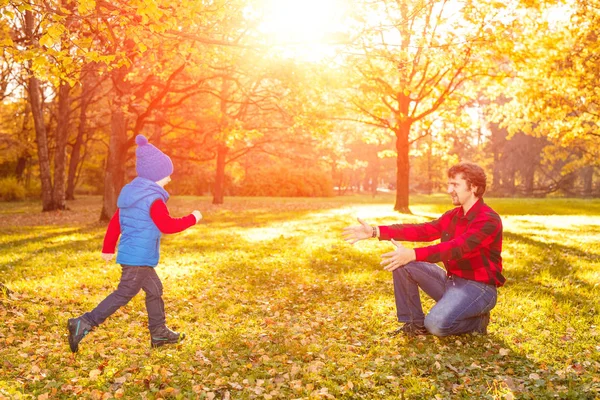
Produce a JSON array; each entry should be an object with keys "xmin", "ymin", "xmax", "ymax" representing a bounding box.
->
[{"xmin": 346, "ymin": 0, "xmax": 510, "ymax": 212}]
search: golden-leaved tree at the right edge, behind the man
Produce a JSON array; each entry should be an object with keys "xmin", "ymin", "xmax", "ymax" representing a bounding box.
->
[{"xmin": 487, "ymin": 1, "xmax": 600, "ymax": 194}]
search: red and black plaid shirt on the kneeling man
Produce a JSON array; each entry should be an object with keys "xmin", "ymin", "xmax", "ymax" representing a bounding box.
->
[{"xmin": 379, "ymin": 199, "xmax": 506, "ymax": 286}]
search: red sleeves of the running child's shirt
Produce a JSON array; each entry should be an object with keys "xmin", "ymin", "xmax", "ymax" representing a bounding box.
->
[{"xmin": 102, "ymin": 200, "xmax": 196, "ymax": 254}]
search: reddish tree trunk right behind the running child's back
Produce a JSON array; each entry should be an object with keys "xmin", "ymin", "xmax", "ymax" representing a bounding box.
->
[{"xmin": 100, "ymin": 102, "xmax": 127, "ymax": 221}]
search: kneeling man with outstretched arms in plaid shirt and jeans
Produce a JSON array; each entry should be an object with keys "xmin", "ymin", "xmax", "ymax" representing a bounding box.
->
[{"xmin": 344, "ymin": 162, "xmax": 505, "ymax": 336}]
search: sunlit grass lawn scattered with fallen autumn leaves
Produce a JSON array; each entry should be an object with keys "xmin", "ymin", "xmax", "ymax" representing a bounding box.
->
[{"xmin": 0, "ymin": 196, "xmax": 600, "ymax": 399}]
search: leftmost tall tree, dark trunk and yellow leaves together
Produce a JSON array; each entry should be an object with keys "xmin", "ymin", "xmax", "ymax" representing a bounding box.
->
[{"xmin": 10, "ymin": 1, "xmax": 98, "ymax": 211}]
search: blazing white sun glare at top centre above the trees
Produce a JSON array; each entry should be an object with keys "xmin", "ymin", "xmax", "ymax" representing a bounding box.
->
[{"xmin": 256, "ymin": 0, "xmax": 346, "ymax": 61}]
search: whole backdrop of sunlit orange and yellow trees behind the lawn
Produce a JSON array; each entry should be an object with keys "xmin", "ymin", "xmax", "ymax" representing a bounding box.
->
[{"xmin": 0, "ymin": 0, "xmax": 600, "ymax": 218}]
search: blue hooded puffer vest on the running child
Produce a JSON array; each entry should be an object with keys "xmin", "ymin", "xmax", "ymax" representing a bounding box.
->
[{"xmin": 117, "ymin": 177, "xmax": 169, "ymax": 267}]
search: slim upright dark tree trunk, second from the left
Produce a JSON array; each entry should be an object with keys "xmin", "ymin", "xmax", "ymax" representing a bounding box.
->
[{"xmin": 52, "ymin": 82, "xmax": 71, "ymax": 210}]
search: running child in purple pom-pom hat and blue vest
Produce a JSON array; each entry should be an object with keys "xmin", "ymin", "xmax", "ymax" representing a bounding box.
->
[{"xmin": 67, "ymin": 135, "xmax": 202, "ymax": 353}]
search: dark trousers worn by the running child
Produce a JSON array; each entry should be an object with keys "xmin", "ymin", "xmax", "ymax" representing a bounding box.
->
[{"xmin": 83, "ymin": 265, "xmax": 165, "ymax": 331}]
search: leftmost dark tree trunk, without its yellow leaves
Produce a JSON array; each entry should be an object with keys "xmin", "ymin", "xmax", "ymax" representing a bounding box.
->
[{"xmin": 25, "ymin": 11, "xmax": 54, "ymax": 211}]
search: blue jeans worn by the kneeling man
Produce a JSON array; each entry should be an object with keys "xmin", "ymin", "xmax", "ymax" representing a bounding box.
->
[{"xmin": 393, "ymin": 261, "xmax": 497, "ymax": 336}]
